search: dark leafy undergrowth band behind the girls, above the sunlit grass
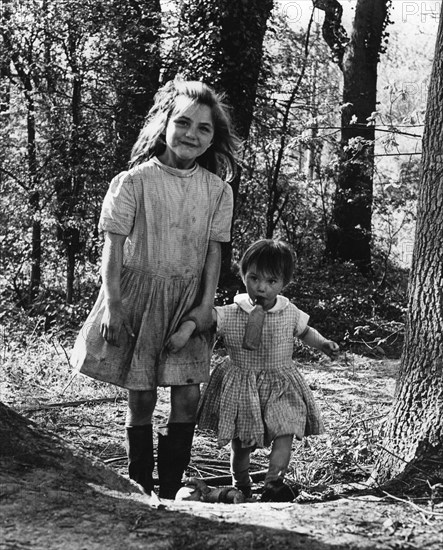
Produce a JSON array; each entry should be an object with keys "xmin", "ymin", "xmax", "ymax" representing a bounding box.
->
[{"xmin": 0, "ymin": 250, "xmax": 408, "ymax": 358}]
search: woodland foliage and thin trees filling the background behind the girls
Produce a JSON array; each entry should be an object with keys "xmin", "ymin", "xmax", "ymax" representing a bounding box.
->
[{"xmin": 0, "ymin": 0, "xmax": 430, "ymax": 358}]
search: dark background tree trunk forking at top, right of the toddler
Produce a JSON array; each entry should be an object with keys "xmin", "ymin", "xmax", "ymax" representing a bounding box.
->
[{"xmin": 314, "ymin": 0, "xmax": 389, "ymax": 273}]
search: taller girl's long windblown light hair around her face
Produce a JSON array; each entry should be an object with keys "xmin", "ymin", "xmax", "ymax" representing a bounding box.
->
[{"xmin": 129, "ymin": 78, "xmax": 239, "ymax": 180}]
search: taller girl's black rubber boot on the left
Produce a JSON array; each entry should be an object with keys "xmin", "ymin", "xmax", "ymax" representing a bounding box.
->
[{"xmin": 125, "ymin": 424, "xmax": 154, "ymax": 495}]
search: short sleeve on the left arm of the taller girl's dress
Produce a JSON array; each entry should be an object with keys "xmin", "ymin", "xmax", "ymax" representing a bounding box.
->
[{"xmin": 99, "ymin": 172, "xmax": 136, "ymax": 235}]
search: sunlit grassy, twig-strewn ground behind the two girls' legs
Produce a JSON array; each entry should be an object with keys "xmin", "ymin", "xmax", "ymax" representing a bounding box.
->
[{"xmin": 0, "ymin": 324, "xmax": 393, "ymax": 496}]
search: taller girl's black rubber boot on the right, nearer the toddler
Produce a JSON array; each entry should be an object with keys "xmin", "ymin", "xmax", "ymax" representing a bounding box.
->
[{"xmin": 157, "ymin": 422, "xmax": 195, "ymax": 499}]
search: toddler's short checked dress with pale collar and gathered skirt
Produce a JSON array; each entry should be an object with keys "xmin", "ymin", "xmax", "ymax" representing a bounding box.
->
[{"xmin": 198, "ymin": 294, "xmax": 324, "ymax": 447}]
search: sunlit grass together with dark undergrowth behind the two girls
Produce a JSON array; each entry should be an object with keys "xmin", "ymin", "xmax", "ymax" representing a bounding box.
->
[{"xmin": 0, "ymin": 253, "xmax": 407, "ymax": 487}]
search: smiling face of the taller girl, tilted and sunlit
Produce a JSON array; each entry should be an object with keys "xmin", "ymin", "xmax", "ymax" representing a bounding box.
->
[{"xmin": 159, "ymin": 96, "xmax": 214, "ymax": 169}]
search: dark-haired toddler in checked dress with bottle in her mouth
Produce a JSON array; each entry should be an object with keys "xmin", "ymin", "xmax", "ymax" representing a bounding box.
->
[{"xmin": 194, "ymin": 240, "xmax": 339, "ymax": 501}]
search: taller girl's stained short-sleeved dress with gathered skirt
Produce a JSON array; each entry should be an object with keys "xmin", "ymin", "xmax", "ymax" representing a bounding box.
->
[{"xmin": 71, "ymin": 158, "xmax": 232, "ymax": 390}]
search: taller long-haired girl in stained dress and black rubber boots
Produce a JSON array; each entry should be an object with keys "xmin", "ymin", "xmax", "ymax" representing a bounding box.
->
[{"xmin": 72, "ymin": 79, "xmax": 237, "ymax": 504}]
